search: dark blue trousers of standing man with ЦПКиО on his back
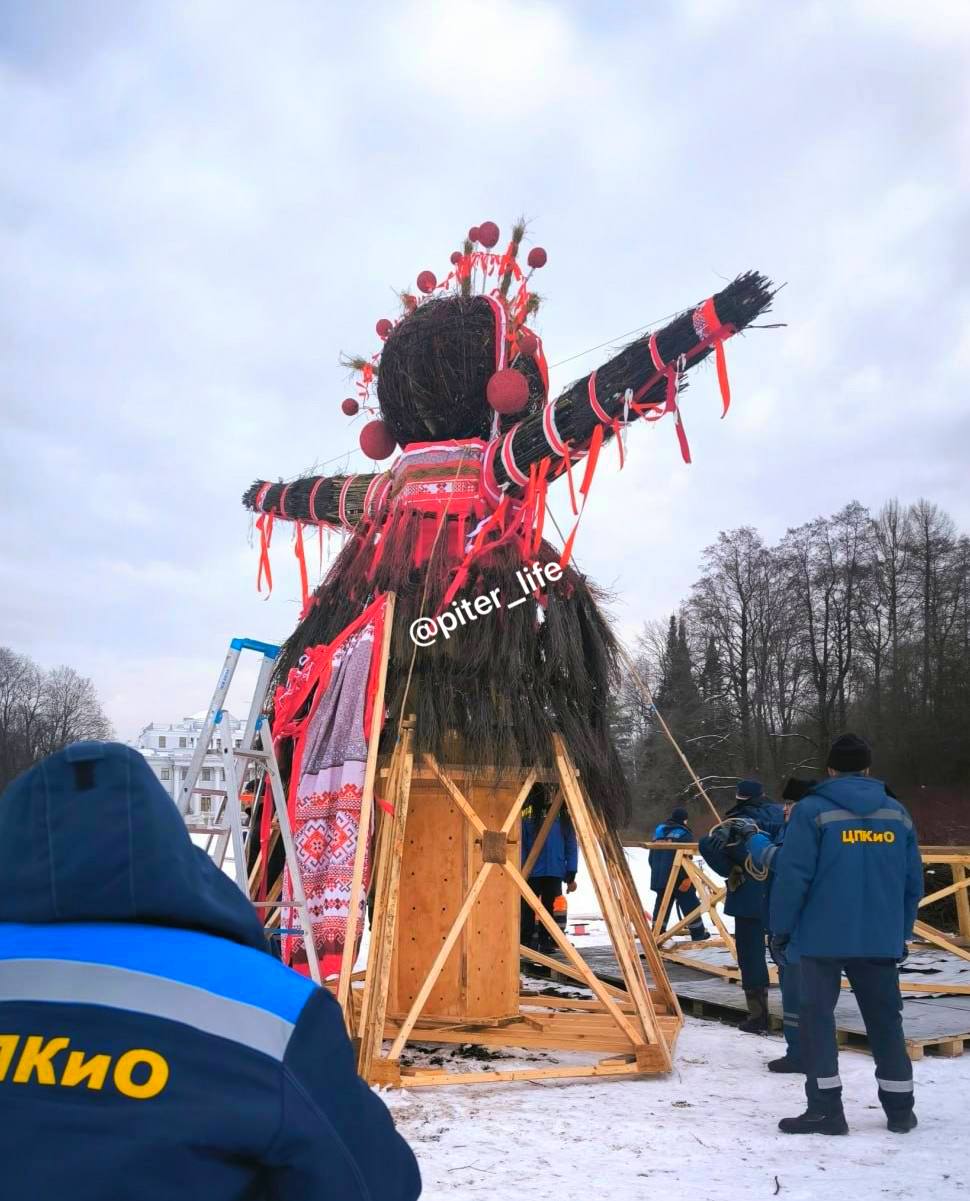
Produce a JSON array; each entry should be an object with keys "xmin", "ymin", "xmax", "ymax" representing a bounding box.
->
[{"xmin": 800, "ymin": 956, "xmax": 912, "ymax": 1115}]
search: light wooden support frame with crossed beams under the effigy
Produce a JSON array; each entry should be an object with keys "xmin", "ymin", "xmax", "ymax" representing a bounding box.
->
[{"xmin": 342, "ymin": 725, "xmax": 683, "ymax": 1087}]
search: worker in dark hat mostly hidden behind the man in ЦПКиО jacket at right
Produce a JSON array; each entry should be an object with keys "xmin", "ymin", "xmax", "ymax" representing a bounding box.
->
[{"xmin": 711, "ymin": 776, "xmax": 816, "ymax": 1074}]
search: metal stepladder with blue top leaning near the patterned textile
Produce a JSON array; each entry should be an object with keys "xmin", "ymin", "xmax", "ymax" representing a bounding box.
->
[{"xmin": 178, "ymin": 638, "xmax": 321, "ymax": 984}]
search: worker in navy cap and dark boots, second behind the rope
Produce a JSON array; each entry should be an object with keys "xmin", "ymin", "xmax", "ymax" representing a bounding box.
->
[{"xmin": 700, "ymin": 779, "xmax": 785, "ymax": 1034}]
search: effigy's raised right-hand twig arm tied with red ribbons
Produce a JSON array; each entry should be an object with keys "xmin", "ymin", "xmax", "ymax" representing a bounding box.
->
[{"xmin": 486, "ymin": 271, "xmax": 774, "ymax": 490}]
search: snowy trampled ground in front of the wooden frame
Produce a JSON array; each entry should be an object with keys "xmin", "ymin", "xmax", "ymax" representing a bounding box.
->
[{"xmin": 383, "ymin": 1018, "xmax": 970, "ymax": 1201}]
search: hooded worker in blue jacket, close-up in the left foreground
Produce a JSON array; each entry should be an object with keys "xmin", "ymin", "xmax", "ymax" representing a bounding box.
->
[{"xmin": 0, "ymin": 742, "xmax": 421, "ymax": 1201}]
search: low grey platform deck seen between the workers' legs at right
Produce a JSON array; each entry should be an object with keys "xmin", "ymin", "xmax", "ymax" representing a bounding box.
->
[{"xmin": 571, "ymin": 948, "xmax": 970, "ymax": 1059}]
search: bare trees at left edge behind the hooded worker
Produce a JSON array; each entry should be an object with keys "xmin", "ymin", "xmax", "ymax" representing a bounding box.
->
[{"xmin": 0, "ymin": 646, "xmax": 112, "ymax": 790}]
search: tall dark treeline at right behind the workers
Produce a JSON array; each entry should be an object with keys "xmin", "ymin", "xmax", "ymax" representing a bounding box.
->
[{"xmin": 613, "ymin": 500, "xmax": 970, "ymax": 830}]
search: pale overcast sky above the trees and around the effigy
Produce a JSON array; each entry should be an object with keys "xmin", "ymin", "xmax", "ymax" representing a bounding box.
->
[{"xmin": 0, "ymin": 0, "xmax": 970, "ymax": 739}]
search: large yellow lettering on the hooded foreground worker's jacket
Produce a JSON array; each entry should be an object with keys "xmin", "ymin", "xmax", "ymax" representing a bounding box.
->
[{"xmin": 0, "ymin": 1034, "xmax": 169, "ymax": 1101}]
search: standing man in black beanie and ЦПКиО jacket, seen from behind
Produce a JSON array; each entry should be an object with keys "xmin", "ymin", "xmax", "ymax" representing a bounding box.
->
[{"xmin": 771, "ymin": 734, "xmax": 923, "ymax": 1135}]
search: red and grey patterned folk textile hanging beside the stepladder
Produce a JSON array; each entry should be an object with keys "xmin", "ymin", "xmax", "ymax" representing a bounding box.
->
[{"xmin": 273, "ymin": 597, "xmax": 385, "ymax": 979}]
